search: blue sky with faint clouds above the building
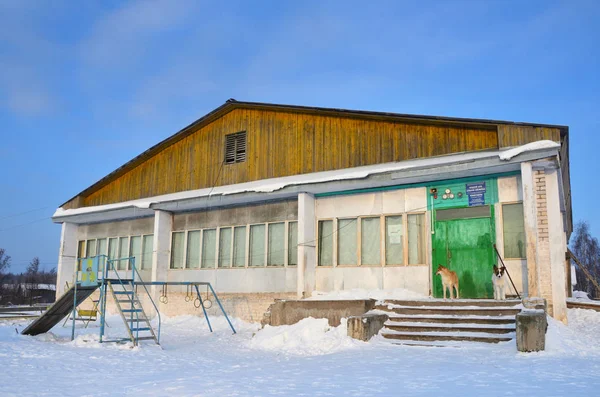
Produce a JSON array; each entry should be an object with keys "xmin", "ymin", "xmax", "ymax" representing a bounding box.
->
[{"xmin": 0, "ymin": 0, "xmax": 600, "ymax": 271}]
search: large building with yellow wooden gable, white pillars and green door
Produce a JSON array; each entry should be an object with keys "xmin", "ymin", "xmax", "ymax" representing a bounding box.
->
[{"xmin": 53, "ymin": 100, "xmax": 572, "ymax": 321}]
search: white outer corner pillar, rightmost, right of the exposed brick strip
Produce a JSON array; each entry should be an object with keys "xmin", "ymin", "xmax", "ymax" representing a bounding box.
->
[{"xmin": 546, "ymin": 168, "xmax": 567, "ymax": 324}]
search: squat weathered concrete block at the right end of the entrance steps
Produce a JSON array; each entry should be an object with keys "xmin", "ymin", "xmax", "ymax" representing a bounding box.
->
[{"xmin": 516, "ymin": 310, "xmax": 548, "ymax": 352}]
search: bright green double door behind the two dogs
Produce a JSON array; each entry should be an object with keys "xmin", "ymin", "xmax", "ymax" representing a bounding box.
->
[{"xmin": 432, "ymin": 206, "xmax": 496, "ymax": 299}]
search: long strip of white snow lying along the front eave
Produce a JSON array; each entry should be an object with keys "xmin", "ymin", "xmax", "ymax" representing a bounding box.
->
[{"xmin": 53, "ymin": 141, "xmax": 560, "ymax": 217}]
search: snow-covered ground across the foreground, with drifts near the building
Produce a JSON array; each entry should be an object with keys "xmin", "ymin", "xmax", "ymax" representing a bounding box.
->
[{"xmin": 0, "ymin": 309, "xmax": 600, "ymax": 397}]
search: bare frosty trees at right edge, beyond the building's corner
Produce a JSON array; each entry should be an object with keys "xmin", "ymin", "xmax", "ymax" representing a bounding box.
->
[{"xmin": 571, "ymin": 221, "xmax": 600, "ymax": 297}]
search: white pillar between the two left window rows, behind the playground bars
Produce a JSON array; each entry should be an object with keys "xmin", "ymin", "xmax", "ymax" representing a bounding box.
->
[{"xmin": 151, "ymin": 210, "xmax": 173, "ymax": 305}]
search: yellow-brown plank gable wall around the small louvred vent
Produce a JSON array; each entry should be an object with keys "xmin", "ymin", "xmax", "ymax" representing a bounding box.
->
[{"xmin": 81, "ymin": 108, "xmax": 498, "ymax": 206}]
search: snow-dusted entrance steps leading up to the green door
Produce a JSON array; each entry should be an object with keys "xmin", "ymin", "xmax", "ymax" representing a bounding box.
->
[{"xmin": 375, "ymin": 299, "xmax": 521, "ymax": 347}]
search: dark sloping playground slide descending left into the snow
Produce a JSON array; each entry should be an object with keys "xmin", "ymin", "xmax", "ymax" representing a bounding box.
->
[{"xmin": 21, "ymin": 285, "xmax": 99, "ymax": 335}]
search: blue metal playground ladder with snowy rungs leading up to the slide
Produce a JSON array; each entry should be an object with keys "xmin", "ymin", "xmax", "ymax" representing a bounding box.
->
[{"xmin": 106, "ymin": 276, "xmax": 160, "ymax": 346}]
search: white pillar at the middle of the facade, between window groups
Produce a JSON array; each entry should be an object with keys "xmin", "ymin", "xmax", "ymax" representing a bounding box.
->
[{"xmin": 297, "ymin": 193, "xmax": 317, "ymax": 298}]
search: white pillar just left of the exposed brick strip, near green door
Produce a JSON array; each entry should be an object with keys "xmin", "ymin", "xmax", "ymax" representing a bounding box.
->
[{"xmin": 521, "ymin": 163, "xmax": 540, "ymax": 297}]
